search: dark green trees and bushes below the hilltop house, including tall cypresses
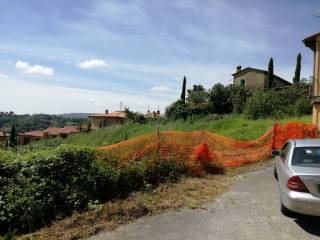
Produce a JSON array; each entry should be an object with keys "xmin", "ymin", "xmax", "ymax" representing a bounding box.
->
[{"xmin": 166, "ymin": 74, "xmax": 312, "ymax": 120}]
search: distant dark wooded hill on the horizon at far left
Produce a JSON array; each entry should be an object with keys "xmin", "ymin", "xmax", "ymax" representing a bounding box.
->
[{"xmin": 0, "ymin": 112, "xmax": 88, "ymax": 133}]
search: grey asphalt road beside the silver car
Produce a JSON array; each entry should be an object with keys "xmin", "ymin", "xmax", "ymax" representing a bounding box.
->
[{"xmin": 91, "ymin": 168, "xmax": 320, "ymax": 240}]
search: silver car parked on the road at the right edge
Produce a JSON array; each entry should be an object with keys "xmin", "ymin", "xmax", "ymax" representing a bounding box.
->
[{"xmin": 273, "ymin": 139, "xmax": 320, "ymax": 216}]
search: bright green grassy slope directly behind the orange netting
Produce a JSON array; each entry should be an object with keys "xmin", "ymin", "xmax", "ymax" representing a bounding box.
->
[{"xmin": 65, "ymin": 115, "xmax": 311, "ymax": 146}]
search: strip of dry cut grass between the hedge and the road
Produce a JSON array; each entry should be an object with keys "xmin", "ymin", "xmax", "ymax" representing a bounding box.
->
[{"xmin": 17, "ymin": 161, "xmax": 272, "ymax": 240}]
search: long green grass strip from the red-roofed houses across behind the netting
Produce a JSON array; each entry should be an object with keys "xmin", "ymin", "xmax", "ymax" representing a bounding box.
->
[{"xmin": 17, "ymin": 114, "xmax": 311, "ymax": 153}]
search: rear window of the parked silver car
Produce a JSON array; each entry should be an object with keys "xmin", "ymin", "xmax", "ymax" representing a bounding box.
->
[{"xmin": 292, "ymin": 147, "xmax": 320, "ymax": 167}]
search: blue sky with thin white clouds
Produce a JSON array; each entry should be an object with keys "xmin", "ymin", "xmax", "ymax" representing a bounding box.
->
[{"xmin": 0, "ymin": 0, "xmax": 320, "ymax": 114}]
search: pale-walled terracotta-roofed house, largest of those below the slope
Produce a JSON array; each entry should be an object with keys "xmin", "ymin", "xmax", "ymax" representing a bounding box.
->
[{"xmin": 89, "ymin": 110, "xmax": 127, "ymax": 128}]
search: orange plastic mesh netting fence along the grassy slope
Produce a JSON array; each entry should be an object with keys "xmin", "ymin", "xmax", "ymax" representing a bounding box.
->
[{"xmin": 99, "ymin": 122, "xmax": 318, "ymax": 167}]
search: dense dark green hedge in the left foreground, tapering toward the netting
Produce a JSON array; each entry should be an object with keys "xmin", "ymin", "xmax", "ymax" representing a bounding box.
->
[{"xmin": 0, "ymin": 146, "xmax": 186, "ymax": 235}]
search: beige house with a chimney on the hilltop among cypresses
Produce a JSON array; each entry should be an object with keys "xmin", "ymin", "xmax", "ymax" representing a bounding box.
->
[{"xmin": 232, "ymin": 66, "xmax": 292, "ymax": 89}]
